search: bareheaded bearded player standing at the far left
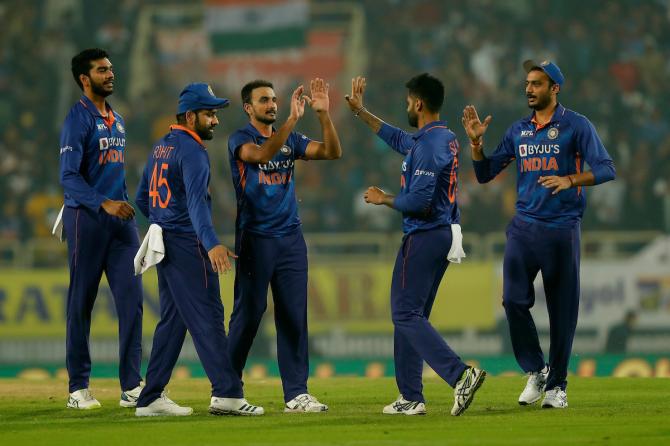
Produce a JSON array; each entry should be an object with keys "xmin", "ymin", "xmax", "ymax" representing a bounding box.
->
[{"xmin": 60, "ymin": 48, "xmax": 142, "ymax": 409}]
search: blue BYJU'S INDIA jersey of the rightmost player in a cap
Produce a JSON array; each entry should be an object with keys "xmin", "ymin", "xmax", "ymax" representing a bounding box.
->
[{"xmin": 473, "ymin": 104, "xmax": 616, "ymax": 227}]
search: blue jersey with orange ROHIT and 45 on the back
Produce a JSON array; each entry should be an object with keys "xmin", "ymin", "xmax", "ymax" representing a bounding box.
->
[{"xmin": 135, "ymin": 125, "xmax": 220, "ymax": 251}]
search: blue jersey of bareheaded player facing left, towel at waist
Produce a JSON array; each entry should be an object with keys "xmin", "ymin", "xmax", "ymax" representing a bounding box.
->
[{"xmin": 377, "ymin": 121, "xmax": 460, "ymax": 234}]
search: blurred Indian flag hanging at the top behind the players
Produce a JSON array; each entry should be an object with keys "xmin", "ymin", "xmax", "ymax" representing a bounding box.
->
[{"xmin": 205, "ymin": 0, "xmax": 309, "ymax": 55}]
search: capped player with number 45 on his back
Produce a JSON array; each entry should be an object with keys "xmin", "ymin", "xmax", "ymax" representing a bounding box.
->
[{"xmin": 135, "ymin": 83, "xmax": 263, "ymax": 416}]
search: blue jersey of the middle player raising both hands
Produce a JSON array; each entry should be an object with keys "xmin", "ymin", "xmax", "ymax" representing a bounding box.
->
[{"xmin": 228, "ymin": 124, "xmax": 311, "ymax": 237}]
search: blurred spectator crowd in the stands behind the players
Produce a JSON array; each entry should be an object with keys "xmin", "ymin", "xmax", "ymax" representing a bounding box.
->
[{"xmin": 0, "ymin": 0, "xmax": 670, "ymax": 240}]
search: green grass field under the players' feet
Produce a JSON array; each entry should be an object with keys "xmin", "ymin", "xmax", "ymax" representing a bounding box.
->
[{"xmin": 0, "ymin": 377, "xmax": 670, "ymax": 446}]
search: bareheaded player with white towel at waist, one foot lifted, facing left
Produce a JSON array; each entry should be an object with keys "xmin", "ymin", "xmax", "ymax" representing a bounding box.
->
[{"xmin": 346, "ymin": 73, "xmax": 486, "ymax": 416}]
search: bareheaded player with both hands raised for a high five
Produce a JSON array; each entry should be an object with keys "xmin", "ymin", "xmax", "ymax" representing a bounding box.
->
[{"xmin": 228, "ymin": 78, "xmax": 342, "ymax": 412}]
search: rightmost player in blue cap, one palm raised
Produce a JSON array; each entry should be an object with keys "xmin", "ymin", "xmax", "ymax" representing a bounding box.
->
[{"xmin": 462, "ymin": 60, "xmax": 615, "ymax": 408}]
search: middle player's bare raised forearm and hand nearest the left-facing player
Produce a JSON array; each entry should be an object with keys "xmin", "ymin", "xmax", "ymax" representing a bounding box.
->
[{"xmin": 304, "ymin": 77, "xmax": 342, "ymax": 160}]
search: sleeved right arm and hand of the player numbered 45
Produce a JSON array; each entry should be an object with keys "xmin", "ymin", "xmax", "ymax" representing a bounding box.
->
[{"xmin": 181, "ymin": 152, "xmax": 236, "ymax": 273}]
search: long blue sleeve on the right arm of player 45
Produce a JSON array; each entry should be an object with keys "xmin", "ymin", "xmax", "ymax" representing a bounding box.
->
[{"xmin": 181, "ymin": 148, "xmax": 221, "ymax": 251}]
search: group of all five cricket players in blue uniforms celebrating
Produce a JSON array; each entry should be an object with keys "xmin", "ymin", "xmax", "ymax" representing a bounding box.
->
[{"xmin": 54, "ymin": 48, "xmax": 615, "ymax": 416}]
